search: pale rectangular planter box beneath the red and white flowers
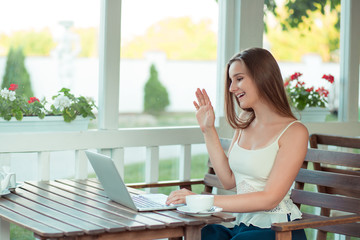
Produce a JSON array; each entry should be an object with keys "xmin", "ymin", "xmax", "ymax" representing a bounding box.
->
[{"xmin": 0, "ymin": 116, "xmax": 90, "ymax": 133}]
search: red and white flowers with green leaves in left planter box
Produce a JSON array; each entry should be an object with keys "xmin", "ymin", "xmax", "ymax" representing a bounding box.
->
[{"xmin": 0, "ymin": 84, "xmax": 96, "ymax": 131}]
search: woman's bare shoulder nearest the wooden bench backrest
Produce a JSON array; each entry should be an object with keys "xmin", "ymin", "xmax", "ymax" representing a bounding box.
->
[{"xmin": 279, "ymin": 122, "xmax": 309, "ymax": 145}]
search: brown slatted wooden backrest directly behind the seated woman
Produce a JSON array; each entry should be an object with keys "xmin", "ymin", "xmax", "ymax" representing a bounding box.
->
[{"xmin": 291, "ymin": 148, "xmax": 360, "ymax": 240}]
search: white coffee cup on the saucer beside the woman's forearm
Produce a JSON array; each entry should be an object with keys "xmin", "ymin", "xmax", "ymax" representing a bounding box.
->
[{"xmin": 185, "ymin": 194, "xmax": 214, "ymax": 212}]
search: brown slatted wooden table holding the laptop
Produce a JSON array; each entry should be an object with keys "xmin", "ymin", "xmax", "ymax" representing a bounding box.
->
[{"xmin": 0, "ymin": 179, "xmax": 234, "ymax": 240}]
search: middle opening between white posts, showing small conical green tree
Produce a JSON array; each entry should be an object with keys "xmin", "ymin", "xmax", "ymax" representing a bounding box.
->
[{"xmin": 119, "ymin": 0, "xmax": 218, "ymax": 128}]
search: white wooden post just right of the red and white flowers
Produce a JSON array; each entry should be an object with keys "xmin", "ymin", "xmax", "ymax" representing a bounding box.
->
[{"xmin": 98, "ymin": 0, "xmax": 121, "ymax": 129}]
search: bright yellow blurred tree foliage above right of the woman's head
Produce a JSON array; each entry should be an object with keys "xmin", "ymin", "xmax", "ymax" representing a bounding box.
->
[{"xmin": 266, "ymin": 8, "xmax": 340, "ymax": 62}]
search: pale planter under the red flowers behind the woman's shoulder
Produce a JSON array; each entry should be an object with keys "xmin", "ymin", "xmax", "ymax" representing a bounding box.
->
[{"xmin": 292, "ymin": 107, "xmax": 330, "ymax": 122}]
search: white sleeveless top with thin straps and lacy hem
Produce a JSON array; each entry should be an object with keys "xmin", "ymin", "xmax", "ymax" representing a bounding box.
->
[{"xmin": 229, "ymin": 121, "xmax": 302, "ymax": 228}]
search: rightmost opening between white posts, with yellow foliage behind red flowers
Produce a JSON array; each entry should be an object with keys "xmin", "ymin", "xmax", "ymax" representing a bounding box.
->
[{"xmin": 264, "ymin": 1, "xmax": 340, "ymax": 121}]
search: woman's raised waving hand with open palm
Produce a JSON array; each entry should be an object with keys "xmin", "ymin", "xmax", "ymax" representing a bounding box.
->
[{"xmin": 193, "ymin": 88, "xmax": 215, "ymax": 133}]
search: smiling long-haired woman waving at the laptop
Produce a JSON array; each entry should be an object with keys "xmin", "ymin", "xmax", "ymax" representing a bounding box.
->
[{"xmin": 167, "ymin": 48, "xmax": 308, "ymax": 239}]
